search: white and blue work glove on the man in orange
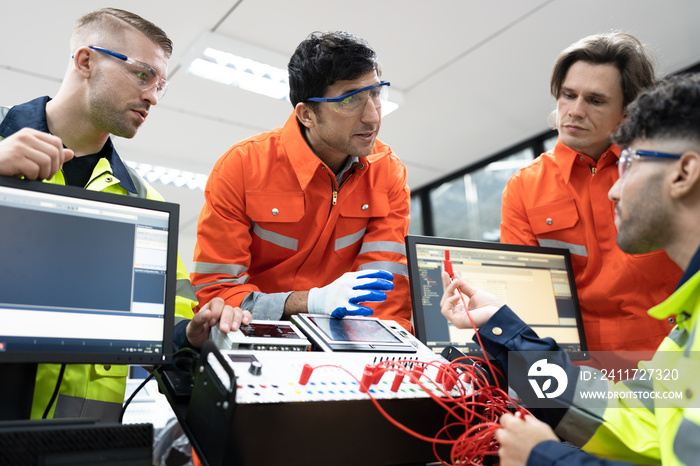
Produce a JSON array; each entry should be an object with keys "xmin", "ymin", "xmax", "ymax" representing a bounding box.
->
[{"xmin": 307, "ymin": 270, "xmax": 394, "ymax": 319}]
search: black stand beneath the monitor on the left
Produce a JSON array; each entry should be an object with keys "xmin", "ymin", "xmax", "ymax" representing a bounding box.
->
[{"xmin": 0, "ymin": 362, "xmax": 38, "ymax": 421}]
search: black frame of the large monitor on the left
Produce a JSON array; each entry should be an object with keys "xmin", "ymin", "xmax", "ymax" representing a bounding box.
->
[{"xmin": 0, "ymin": 176, "xmax": 180, "ymax": 366}]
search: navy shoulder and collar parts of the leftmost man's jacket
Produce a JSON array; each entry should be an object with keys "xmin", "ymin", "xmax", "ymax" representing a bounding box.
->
[{"xmin": 0, "ymin": 96, "xmax": 137, "ymax": 194}]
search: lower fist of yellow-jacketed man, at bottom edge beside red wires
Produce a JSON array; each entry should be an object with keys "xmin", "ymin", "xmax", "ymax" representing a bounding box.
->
[{"xmin": 495, "ymin": 414, "xmax": 559, "ymax": 466}]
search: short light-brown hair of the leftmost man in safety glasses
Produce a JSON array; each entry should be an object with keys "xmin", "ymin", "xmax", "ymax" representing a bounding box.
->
[{"xmin": 71, "ymin": 8, "xmax": 173, "ymax": 58}]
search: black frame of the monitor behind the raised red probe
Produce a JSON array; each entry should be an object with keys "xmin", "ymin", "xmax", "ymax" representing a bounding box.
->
[{"xmin": 405, "ymin": 235, "xmax": 590, "ymax": 360}]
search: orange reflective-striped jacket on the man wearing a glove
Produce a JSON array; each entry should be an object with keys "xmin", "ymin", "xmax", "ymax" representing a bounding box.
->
[{"xmin": 191, "ymin": 113, "xmax": 411, "ymax": 329}]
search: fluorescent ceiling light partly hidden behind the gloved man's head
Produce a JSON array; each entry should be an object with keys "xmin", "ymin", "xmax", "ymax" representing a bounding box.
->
[{"xmin": 183, "ymin": 32, "xmax": 403, "ymax": 116}]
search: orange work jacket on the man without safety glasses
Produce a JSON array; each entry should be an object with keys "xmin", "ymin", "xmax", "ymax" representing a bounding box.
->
[{"xmin": 501, "ymin": 141, "xmax": 681, "ymax": 351}]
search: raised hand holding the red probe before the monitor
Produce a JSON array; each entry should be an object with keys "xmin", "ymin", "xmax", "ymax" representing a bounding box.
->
[{"xmin": 440, "ymin": 272, "xmax": 503, "ymax": 328}]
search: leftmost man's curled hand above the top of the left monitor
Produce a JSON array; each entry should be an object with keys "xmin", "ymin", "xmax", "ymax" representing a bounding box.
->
[{"xmin": 0, "ymin": 128, "xmax": 73, "ymax": 180}]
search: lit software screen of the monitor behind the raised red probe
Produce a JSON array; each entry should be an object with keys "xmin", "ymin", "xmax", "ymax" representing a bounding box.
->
[{"xmin": 414, "ymin": 244, "xmax": 581, "ymax": 353}]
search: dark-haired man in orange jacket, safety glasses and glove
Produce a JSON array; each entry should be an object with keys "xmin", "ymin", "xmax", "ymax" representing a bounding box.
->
[{"xmin": 191, "ymin": 32, "xmax": 411, "ymax": 329}]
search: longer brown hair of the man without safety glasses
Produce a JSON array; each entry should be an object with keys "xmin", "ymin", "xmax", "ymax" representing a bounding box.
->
[{"xmin": 550, "ymin": 32, "xmax": 655, "ymax": 106}]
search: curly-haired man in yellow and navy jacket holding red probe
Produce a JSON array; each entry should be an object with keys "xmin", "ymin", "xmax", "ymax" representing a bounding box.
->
[{"xmin": 442, "ymin": 75, "xmax": 700, "ymax": 466}]
